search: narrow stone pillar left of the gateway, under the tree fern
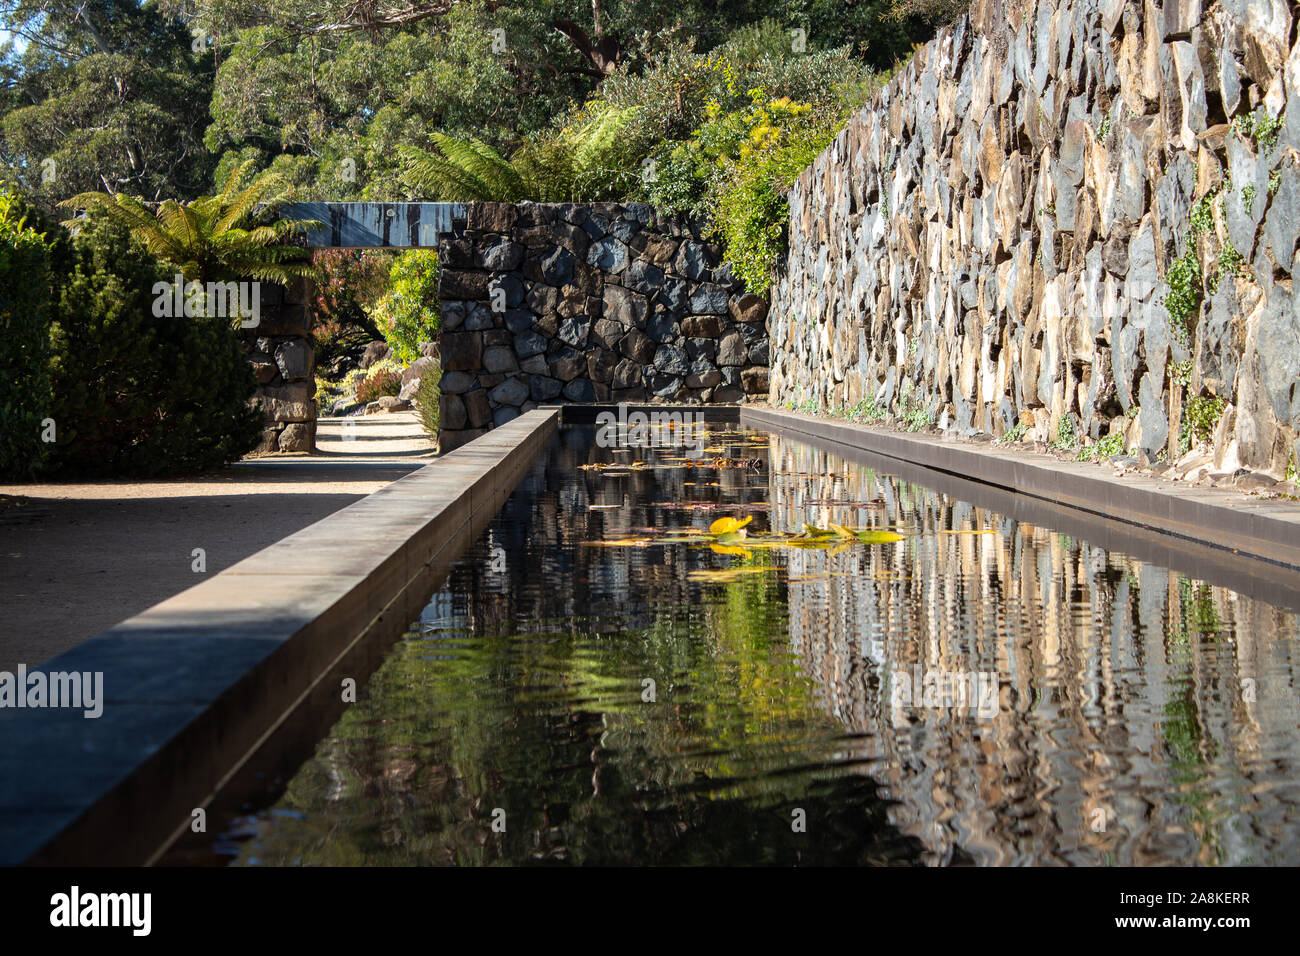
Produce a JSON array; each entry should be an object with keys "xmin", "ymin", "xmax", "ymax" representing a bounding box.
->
[{"xmin": 243, "ymin": 280, "xmax": 316, "ymax": 454}]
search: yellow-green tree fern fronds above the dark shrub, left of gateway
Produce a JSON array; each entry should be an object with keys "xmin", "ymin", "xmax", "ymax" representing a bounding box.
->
[{"xmin": 60, "ymin": 163, "xmax": 320, "ymax": 284}]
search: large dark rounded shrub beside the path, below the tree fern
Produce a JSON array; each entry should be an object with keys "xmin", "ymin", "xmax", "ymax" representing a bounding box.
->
[{"xmin": 43, "ymin": 216, "xmax": 263, "ymax": 476}]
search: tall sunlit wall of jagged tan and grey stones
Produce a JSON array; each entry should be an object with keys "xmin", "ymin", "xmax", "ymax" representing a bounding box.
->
[{"xmin": 768, "ymin": 0, "xmax": 1300, "ymax": 477}]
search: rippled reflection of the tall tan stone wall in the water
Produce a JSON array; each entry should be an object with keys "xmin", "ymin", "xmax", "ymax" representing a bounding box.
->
[{"xmin": 771, "ymin": 440, "xmax": 1300, "ymax": 865}]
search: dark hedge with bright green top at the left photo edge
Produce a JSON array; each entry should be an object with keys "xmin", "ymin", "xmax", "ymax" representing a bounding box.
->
[{"xmin": 0, "ymin": 191, "xmax": 51, "ymax": 479}]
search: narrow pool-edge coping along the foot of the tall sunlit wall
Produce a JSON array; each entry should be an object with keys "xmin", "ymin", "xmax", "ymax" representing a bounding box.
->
[{"xmin": 741, "ymin": 407, "xmax": 1300, "ymax": 588}]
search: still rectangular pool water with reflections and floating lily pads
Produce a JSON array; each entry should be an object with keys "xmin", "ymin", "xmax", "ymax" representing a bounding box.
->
[{"xmin": 220, "ymin": 425, "xmax": 1300, "ymax": 865}]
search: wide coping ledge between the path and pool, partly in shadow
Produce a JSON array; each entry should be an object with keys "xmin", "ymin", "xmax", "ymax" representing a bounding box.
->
[{"xmin": 0, "ymin": 408, "xmax": 560, "ymax": 865}]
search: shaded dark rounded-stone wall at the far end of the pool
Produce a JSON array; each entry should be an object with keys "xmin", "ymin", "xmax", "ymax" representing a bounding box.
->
[{"xmin": 438, "ymin": 203, "xmax": 768, "ymax": 451}]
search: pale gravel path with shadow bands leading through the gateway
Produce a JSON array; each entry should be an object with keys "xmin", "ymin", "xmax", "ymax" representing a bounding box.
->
[{"xmin": 0, "ymin": 412, "xmax": 434, "ymax": 671}]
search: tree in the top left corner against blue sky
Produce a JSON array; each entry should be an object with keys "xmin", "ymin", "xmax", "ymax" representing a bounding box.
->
[{"xmin": 0, "ymin": 0, "xmax": 212, "ymax": 206}]
